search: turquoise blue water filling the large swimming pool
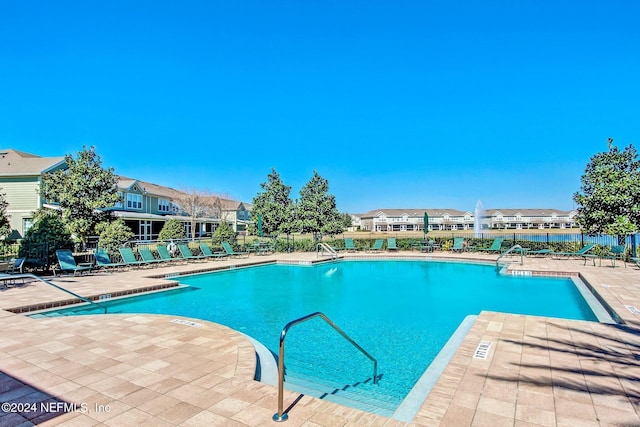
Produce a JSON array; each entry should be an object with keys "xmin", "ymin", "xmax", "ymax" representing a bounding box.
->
[{"xmin": 35, "ymin": 261, "xmax": 597, "ymax": 414}]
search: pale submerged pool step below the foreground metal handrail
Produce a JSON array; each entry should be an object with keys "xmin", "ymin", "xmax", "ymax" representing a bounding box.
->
[{"xmin": 285, "ymin": 375, "xmax": 400, "ymax": 417}]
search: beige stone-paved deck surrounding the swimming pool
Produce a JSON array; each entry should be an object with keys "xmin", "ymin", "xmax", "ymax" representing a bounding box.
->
[{"xmin": 0, "ymin": 252, "xmax": 640, "ymax": 427}]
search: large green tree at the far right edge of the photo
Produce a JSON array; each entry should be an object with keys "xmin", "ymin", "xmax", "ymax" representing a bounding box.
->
[{"xmin": 573, "ymin": 138, "xmax": 640, "ymax": 244}]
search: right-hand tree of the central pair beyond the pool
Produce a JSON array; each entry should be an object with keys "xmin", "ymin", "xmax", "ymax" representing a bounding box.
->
[{"xmin": 295, "ymin": 171, "xmax": 342, "ymax": 240}]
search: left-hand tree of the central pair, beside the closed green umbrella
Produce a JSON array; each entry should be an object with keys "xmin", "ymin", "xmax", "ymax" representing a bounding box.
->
[{"xmin": 251, "ymin": 168, "xmax": 293, "ymax": 235}]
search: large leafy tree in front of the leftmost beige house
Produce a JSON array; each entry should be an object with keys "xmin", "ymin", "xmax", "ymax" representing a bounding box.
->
[{"xmin": 41, "ymin": 147, "xmax": 120, "ymax": 243}]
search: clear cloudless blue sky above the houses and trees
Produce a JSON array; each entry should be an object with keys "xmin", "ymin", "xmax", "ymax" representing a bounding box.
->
[{"xmin": 0, "ymin": 0, "xmax": 640, "ymax": 213}]
